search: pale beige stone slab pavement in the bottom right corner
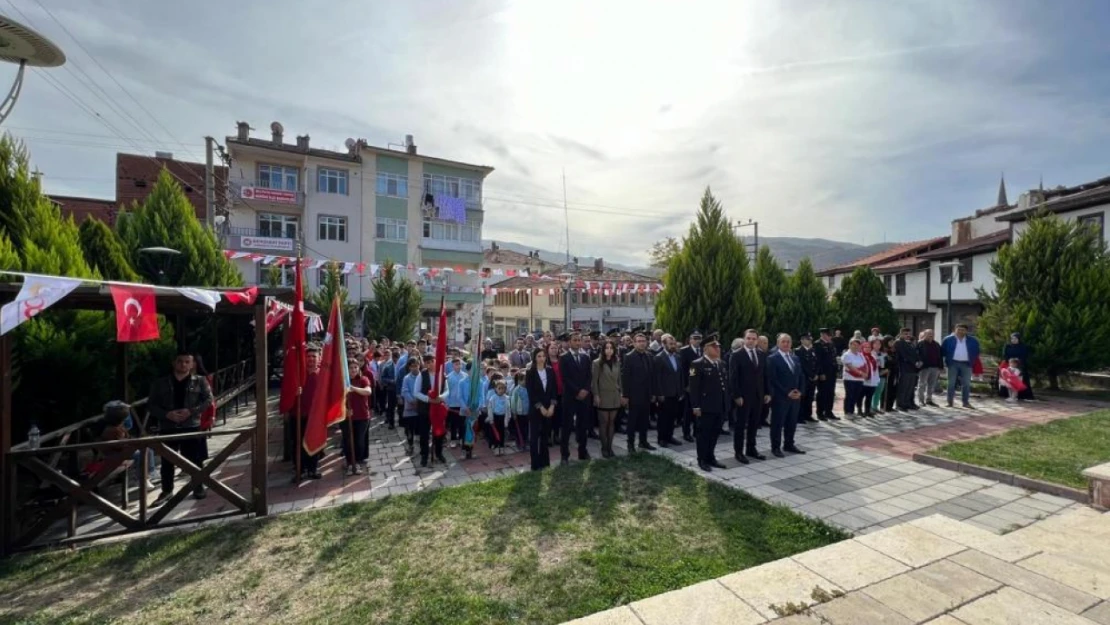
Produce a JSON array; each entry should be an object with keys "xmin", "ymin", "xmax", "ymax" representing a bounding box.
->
[{"xmin": 568, "ymin": 508, "xmax": 1110, "ymax": 625}]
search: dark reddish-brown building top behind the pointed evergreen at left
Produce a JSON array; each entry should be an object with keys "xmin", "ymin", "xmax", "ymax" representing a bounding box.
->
[{"xmin": 115, "ymin": 152, "xmax": 228, "ymax": 220}]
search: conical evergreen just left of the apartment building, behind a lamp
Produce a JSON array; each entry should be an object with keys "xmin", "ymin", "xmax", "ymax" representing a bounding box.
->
[{"xmin": 118, "ymin": 169, "xmax": 243, "ymax": 286}]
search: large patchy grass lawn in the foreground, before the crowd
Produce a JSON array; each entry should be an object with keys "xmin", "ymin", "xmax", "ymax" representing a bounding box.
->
[{"xmin": 0, "ymin": 454, "xmax": 847, "ymax": 625}]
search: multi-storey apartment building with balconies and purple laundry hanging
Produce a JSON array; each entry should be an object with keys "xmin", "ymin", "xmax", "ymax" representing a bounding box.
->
[{"xmin": 225, "ymin": 122, "xmax": 493, "ymax": 323}]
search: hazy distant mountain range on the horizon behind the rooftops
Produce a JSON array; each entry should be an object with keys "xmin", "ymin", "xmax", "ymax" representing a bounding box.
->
[{"xmin": 482, "ymin": 236, "xmax": 898, "ymax": 275}]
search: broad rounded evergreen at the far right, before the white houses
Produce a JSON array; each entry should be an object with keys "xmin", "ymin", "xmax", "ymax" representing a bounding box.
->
[{"xmin": 977, "ymin": 215, "xmax": 1110, "ymax": 389}]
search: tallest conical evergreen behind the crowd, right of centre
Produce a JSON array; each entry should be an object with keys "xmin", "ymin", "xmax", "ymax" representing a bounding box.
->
[{"xmin": 655, "ymin": 188, "xmax": 764, "ymax": 345}]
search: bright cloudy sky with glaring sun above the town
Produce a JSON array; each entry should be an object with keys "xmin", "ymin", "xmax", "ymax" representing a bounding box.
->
[{"xmin": 0, "ymin": 0, "xmax": 1110, "ymax": 264}]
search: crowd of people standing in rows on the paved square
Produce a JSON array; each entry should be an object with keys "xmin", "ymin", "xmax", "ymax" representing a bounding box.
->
[{"xmin": 279, "ymin": 324, "xmax": 1032, "ymax": 478}]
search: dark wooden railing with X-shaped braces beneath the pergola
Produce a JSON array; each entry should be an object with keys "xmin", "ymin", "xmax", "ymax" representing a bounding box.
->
[{"xmin": 0, "ymin": 361, "xmax": 257, "ymax": 553}]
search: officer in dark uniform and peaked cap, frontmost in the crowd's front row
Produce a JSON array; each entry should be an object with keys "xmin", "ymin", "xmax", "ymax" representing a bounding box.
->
[{"xmin": 689, "ymin": 334, "xmax": 729, "ymax": 471}]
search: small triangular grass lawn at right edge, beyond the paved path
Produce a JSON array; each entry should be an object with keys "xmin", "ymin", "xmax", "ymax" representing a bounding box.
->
[{"xmin": 930, "ymin": 411, "xmax": 1110, "ymax": 488}]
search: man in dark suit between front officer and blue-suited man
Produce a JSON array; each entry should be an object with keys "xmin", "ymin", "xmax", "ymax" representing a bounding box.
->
[{"xmin": 728, "ymin": 330, "xmax": 769, "ymax": 464}]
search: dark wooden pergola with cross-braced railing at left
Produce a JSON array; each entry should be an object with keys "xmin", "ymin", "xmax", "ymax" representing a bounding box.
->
[{"xmin": 0, "ymin": 283, "xmax": 292, "ymax": 555}]
